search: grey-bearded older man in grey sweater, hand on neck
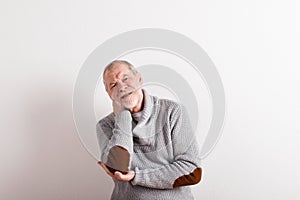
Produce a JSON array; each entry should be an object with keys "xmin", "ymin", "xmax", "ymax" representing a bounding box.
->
[{"xmin": 97, "ymin": 60, "xmax": 202, "ymax": 200}]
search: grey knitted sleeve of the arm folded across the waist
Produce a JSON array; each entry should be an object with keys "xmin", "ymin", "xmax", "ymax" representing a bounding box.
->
[{"xmin": 132, "ymin": 106, "xmax": 202, "ymax": 189}]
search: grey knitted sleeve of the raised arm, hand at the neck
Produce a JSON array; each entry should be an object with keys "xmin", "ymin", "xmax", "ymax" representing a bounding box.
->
[{"xmin": 96, "ymin": 110, "xmax": 133, "ymax": 173}]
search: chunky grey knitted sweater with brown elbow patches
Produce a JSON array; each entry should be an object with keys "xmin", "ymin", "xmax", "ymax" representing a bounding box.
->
[{"xmin": 97, "ymin": 89, "xmax": 202, "ymax": 200}]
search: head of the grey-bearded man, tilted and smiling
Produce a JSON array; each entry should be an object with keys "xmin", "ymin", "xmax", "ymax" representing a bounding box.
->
[{"xmin": 103, "ymin": 60, "xmax": 143, "ymax": 109}]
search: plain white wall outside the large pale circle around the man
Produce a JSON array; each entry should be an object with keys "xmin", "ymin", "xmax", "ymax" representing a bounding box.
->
[{"xmin": 0, "ymin": 0, "xmax": 300, "ymax": 200}]
